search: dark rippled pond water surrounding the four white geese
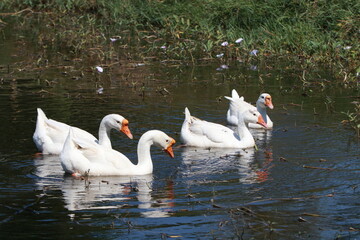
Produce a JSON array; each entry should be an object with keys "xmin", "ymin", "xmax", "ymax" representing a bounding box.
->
[{"xmin": 0, "ymin": 23, "xmax": 360, "ymax": 239}]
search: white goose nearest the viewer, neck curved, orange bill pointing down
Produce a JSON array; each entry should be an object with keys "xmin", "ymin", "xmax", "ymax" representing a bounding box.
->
[{"xmin": 60, "ymin": 128, "xmax": 175, "ymax": 176}]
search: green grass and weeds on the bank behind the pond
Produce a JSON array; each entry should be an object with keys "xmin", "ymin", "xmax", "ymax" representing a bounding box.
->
[{"xmin": 0, "ymin": 0, "xmax": 360, "ymax": 72}]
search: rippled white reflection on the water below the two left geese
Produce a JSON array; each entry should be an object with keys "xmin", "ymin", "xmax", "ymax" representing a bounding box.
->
[{"xmin": 34, "ymin": 156, "xmax": 174, "ymax": 218}]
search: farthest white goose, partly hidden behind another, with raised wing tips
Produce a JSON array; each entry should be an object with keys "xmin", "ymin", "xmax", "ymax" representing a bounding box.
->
[{"xmin": 225, "ymin": 89, "xmax": 274, "ymax": 129}]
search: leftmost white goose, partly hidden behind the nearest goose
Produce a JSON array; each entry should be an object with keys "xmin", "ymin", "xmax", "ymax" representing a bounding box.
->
[{"xmin": 33, "ymin": 108, "xmax": 133, "ymax": 154}]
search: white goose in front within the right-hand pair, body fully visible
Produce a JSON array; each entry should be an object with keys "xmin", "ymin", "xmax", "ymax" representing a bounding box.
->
[{"xmin": 180, "ymin": 108, "xmax": 266, "ymax": 148}]
